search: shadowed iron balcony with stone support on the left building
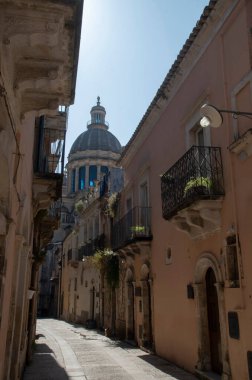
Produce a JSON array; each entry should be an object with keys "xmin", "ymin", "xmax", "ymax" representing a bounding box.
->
[{"xmin": 33, "ymin": 111, "xmax": 67, "ymax": 214}]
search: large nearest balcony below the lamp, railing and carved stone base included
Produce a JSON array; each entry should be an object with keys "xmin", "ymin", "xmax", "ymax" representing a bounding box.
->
[{"xmin": 161, "ymin": 146, "xmax": 224, "ymax": 238}]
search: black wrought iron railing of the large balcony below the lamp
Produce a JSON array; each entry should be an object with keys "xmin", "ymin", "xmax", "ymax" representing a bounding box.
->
[{"xmin": 161, "ymin": 146, "xmax": 224, "ymax": 220}]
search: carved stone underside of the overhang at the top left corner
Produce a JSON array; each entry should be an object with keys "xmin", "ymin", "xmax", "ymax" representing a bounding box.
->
[{"xmin": 0, "ymin": 0, "xmax": 82, "ymax": 118}]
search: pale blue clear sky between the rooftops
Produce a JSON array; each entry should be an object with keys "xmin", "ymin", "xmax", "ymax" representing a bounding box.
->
[{"xmin": 66, "ymin": 0, "xmax": 209, "ymax": 155}]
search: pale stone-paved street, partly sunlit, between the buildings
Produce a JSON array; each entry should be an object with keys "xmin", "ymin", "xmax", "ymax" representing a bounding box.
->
[{"xmin": 23, "ymin": 319, "xmax": 196, "ymax": 380}]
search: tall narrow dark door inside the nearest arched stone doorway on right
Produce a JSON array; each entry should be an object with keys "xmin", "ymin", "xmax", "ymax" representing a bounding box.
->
[{"xmin": 206, "ymin": 268, "xmax": 222, "ymax": 374}]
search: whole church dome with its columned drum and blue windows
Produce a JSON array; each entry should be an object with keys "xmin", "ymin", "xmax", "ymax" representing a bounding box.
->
[{"xmin": 67, "ymin": 96, "xmax": 122, "ymax": 196}]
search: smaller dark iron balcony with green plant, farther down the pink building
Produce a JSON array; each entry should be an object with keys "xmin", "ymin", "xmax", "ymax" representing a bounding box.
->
[{"xmin": 111, "ymin": 206, "xmax": 152, "ymax": 250}]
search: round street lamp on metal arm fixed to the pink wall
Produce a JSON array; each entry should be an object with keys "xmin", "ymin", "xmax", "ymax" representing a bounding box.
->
[{"xmin": 200, "ymin": 104, "xmax": 252, "ymax": 128}]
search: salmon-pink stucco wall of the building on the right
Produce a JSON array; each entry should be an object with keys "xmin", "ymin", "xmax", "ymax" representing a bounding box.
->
[{"xmin": 121, "ymin": 1, "xmax": 252, "ymax": 380}]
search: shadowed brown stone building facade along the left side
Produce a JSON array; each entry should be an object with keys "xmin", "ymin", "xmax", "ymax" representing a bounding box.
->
[{"xmin": 0, "ymin": 0, "xmax": 83, "ymax": 380}]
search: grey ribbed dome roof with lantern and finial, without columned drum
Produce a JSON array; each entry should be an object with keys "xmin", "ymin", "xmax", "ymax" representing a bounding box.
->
[{"xmin": 70, "ymin": 97, "xmax": 122, "ymax": 155}]
